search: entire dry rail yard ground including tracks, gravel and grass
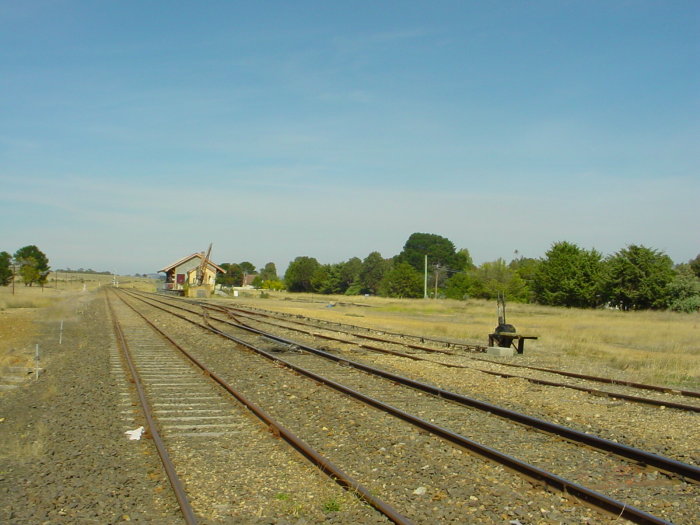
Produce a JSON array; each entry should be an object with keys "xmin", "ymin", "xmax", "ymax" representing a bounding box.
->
[{"xmin": 0, "ymin": 282, "xmax": 700, "ymax": 525}]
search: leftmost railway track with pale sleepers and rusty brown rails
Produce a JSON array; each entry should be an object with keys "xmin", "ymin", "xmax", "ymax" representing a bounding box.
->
[{"xmin": 109, "ymin": 290, "xmax": 400, "ymax": 524}]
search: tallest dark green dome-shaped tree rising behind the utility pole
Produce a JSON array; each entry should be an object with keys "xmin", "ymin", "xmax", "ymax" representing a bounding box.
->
[{"xmin": 395, "ymin": 233, "xmax": 470, "ymax": 273}]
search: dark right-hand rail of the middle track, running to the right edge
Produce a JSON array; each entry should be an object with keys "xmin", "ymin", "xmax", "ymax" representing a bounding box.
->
[{"xmin": 135, "ymin": 288, "xmax": 700, "ymax": 482}]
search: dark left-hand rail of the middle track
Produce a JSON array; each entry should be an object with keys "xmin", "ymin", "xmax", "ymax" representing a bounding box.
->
[{"xmin": 123, "ymin": 288, "xmax": 670, "ymax": 525}]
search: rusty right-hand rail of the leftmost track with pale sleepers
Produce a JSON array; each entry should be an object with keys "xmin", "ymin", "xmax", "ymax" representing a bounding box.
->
[{"xmin": 117, "ymin": 290, "xmax": 413, "ymax": 525}]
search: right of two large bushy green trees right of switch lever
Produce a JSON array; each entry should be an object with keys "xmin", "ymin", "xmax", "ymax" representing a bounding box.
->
[{"xmin": 605, "ymin": 244, "xmax": 675, "ymax": 310}]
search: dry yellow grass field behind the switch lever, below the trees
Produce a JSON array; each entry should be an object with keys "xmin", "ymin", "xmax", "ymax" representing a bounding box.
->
[{"xmin": 226, "ymin": 292, "xmax": 700, "ymax": 389}]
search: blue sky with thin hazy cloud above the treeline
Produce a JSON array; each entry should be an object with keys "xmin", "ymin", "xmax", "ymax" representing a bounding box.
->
[{"xmin": 0, "ymin": 0, "xmax": 700, "ymax": 273}]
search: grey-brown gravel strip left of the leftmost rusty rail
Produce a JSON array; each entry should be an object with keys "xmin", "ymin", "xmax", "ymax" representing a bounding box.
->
[{"xmin": 0, "ymin": 293, "xmax": 179, "ymax": 524}]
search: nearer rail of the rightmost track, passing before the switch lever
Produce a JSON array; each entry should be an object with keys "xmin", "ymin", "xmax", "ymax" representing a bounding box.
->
[{"xmin": 211, "ymin": 303, "xmax": 700, "ymax": 412}]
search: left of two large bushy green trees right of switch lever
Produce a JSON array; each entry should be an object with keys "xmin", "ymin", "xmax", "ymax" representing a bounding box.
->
[{"xmin": 532, "ymin": 241, "xmax": 604, "ymax": 308}]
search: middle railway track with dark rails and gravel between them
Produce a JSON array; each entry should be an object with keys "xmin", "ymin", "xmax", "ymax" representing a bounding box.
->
[{"xmin": 119, "ymin": 288, "xmax": 700, "ymax": 523}]
